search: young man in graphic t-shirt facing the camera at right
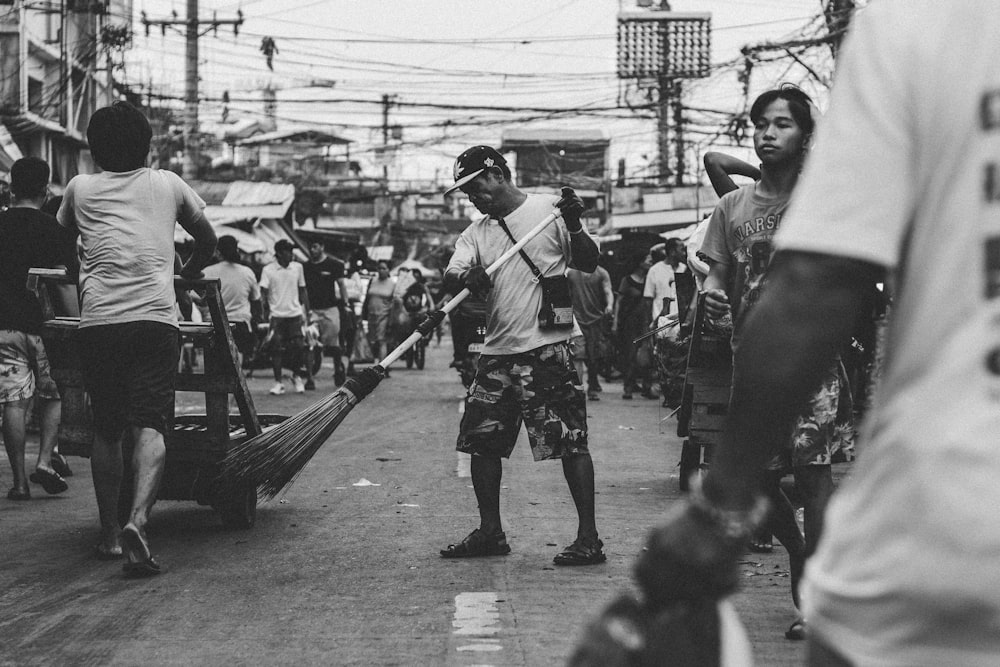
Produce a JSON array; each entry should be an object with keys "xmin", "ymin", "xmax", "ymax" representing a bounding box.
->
[{"xmin": 701, "ymin": 87, "xmax": 841, "ymax": 639}]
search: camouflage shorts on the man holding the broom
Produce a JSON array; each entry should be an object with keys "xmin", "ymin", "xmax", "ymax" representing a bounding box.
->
[{"xmin": 457, "ymin": 343, "xmax": 588, "ymax": 461}]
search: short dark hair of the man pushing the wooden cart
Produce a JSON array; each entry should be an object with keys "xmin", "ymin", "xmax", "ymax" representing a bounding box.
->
[{"xmin": 87, "ymin": 100, "xmax": 153, "ymax": 172}]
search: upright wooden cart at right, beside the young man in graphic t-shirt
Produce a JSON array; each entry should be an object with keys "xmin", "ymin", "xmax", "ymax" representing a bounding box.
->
[{"xmin": 677, "ymin": 294, "xmax": 733, "ymax": 491}]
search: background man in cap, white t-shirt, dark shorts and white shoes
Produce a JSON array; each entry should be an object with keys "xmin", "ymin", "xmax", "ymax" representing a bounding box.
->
[{"xmin": 260, "ymin": 239, "xmax": 311, "ymax": 396}]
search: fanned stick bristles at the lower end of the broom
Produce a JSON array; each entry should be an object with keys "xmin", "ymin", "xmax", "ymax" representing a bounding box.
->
[{"xmin": 218, "ymin": 366, "xmax": 385, "ymax": 500}]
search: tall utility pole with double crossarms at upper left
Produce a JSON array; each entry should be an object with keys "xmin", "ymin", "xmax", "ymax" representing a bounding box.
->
[{"xmin": 142, "ymin": 0, "xmax": 243, "ymax": 180}]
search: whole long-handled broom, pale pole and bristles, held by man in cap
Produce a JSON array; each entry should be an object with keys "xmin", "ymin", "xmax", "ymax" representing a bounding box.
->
[{"xmin": 219, "ymin": 209, "xmax": 561, "ymax": 500}]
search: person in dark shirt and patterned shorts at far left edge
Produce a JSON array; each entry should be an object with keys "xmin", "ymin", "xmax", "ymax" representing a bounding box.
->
[{"xmin": 0, "ymin": 157, "xmax": 76, "ymax": 500}]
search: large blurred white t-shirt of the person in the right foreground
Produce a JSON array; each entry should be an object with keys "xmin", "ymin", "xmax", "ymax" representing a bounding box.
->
[{"xmin": 776, "ymin": 0, "xmax": 1000, "ymax": 667}]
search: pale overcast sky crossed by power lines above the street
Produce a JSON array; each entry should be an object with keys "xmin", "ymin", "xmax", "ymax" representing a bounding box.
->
[{"xmin": 125, "ymin": 0, "xmax": 844, "ymax": 181}]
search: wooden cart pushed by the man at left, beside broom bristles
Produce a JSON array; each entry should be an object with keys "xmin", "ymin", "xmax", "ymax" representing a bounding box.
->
[{"xmin": 28, "ymin": 269, "xmax": 286, "ymax": 528}]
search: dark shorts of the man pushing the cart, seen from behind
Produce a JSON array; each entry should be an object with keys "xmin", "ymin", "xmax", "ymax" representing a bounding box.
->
[{"xmin": 78, "ymin": 322, "xmax": 180, "ymax": 440}]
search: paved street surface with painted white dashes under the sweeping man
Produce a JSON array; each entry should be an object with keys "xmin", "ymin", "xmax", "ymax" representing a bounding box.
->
[{"xmin": 0, "ymin": 338, "xmax": 802, "ymax": 666}]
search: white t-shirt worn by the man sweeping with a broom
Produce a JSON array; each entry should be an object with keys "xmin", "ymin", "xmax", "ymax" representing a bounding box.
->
[{"xmin": 447, "ymin": 194, "xmax": 587, "ymax": 354}]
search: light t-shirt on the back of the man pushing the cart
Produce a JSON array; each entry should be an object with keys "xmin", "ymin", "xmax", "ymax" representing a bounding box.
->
[{"xmin": 57, "ymin": 168, "xmax": 205, "ymax": 327}]
